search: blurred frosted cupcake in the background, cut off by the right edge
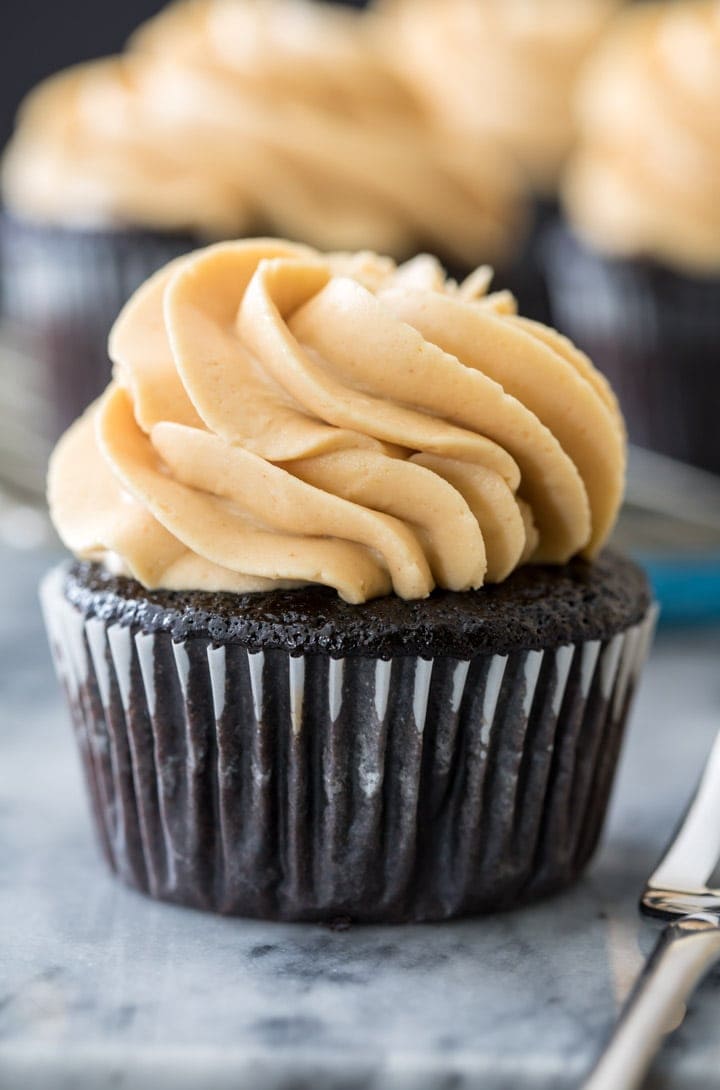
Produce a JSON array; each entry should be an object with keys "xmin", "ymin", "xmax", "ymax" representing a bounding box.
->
[{"xmin": 545, "ymin": 0, "xmax": 720, "ymax": 472}]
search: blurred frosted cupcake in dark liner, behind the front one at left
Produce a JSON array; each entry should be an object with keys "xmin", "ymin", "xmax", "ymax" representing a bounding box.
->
[{"xmin": 1, "ymin": 0, "xmax": 522, "ymax": 494}]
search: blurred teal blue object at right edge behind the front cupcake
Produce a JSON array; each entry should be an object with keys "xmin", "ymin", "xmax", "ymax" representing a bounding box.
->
[{"xmin": 635, "ymin": 552, "xmax": 720, "ymax": 626}]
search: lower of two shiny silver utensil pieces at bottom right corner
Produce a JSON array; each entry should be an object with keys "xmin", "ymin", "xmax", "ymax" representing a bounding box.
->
[{"xmin": 583, "ymin": 912, "xmax": 720, "ymax": 1090}]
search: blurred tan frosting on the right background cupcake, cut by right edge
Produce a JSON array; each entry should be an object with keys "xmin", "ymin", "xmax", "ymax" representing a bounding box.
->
[{"xmin": 564, "ymin": 0, "xmax": 720, "ymax": 275}]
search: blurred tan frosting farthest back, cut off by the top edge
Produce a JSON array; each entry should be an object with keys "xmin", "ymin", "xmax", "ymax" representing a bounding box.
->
[{"xmin": 381, "ymin": 0, "xmax": 620, "ymax": 193}]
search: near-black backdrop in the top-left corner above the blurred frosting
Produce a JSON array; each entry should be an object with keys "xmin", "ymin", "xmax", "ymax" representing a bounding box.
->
[{"xmin": 0, "ymin": 0, "xmax": 363, "ymax": 147}]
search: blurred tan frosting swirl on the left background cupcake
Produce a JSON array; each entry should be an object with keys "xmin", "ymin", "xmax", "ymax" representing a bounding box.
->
[{"xmin": 3, "ymin": 0, "xmax": 523, "ymax": 267}]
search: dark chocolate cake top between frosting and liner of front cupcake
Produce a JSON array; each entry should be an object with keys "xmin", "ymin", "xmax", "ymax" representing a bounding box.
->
[{"xmin": 65, "ymin": 552, "xmax": 651, "ymax": 658}]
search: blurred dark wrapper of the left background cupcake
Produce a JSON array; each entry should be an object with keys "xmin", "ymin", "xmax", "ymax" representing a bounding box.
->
[{"xmin": 0, "ymin": 213, "xmax": 197, "ymax": 491}]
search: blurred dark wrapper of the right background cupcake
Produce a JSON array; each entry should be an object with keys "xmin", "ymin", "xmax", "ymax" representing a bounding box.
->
[{"xmin": 541, "ymin": 223, "xmax": 720, "ymax": 473}]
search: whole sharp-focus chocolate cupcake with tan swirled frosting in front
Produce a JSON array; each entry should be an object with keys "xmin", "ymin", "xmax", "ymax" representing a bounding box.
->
[{"xmin": 41, "ymin": 240, "xmax": 654, "ymax": 922}]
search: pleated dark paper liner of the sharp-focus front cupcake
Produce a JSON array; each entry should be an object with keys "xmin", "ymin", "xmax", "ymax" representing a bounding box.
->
[{"xmin": 41, "ymin": 567, "xmax": 655, "ymax": 922}]
